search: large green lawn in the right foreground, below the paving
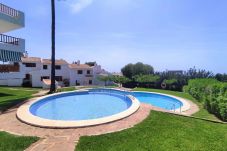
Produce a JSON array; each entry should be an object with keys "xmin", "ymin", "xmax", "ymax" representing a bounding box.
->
[{"xmin": 76, "ymin": 111, "xmax": 227, "ymax": 151}]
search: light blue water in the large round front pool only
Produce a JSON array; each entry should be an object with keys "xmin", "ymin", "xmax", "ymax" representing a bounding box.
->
[{"xmin": 30, "ymin": 92, "xmax": 132, "ymax": 120}]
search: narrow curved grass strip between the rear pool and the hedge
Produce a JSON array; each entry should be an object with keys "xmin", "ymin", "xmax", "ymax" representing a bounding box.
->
[{"xmin": 134, "ymin": 88, "xmax": 220, "ymax": 121}]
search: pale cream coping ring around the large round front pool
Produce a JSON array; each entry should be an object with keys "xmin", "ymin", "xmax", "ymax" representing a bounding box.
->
[{"xmin": 16, "ymin": 89, "xmax": 140, "ymax": 128}]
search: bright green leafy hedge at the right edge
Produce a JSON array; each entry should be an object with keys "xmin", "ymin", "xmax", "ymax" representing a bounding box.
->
[{"xmin": 184, "ymin": 79, "xmax": 227, "ymax": 121}]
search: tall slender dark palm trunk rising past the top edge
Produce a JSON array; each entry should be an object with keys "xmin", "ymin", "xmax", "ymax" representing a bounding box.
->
[{"xmin": 50, "ymin": 0, "xmax": 56, "ymax": 93}]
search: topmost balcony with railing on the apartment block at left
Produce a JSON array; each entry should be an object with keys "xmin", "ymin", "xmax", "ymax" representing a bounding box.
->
[{"xmin": 0, "ymin": 3, "xmax": 24, "ymax": 33}]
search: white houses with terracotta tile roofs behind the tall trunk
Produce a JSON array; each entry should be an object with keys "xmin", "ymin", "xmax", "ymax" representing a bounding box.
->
[{"xmin": 0, "ymin": 57, "xmax": 104, "ymax": 87}]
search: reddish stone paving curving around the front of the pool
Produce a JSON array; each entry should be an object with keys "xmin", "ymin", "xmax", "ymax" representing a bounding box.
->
[{"xmin": 0, "ymin": 90, "xmax": 199, "ymax": 151}]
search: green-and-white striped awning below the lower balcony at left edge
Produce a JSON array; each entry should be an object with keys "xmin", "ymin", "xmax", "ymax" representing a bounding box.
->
[{"xmin": 0, "ymin": 49, "xmax": 23, "ymax": 62}]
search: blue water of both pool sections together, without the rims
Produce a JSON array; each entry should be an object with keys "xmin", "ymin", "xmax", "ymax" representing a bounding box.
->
[{"xmin": 30, "ymin": 89, "xmax": 182, "ymax": 121}]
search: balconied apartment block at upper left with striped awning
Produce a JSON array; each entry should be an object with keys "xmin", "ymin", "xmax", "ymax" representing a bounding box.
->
[{"xmin": 0, "ymin": 3, "xmax": 25, "ymax": 63}]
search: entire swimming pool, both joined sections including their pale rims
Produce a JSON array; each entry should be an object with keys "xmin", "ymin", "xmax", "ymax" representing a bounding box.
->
[{"xmin": 17, "ymin": 89, "xmax": 188, "ymax": 128}]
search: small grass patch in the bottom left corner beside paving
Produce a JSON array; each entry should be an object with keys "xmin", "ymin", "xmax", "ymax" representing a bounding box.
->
[{"xmin": 0, "ymin": 132, "xmax": 38, "ymax": 151}]
